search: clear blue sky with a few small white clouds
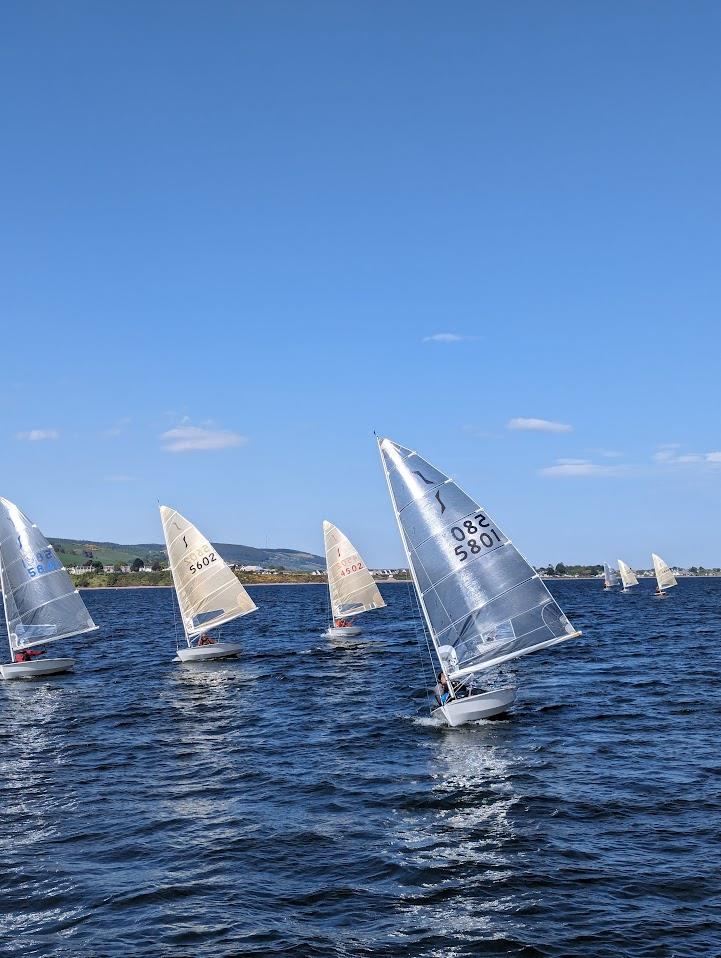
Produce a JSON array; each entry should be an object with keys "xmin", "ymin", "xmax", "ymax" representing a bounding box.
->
[{"xmin": 0, "ymin": 0, "xmax": 721, "ymax": 567}]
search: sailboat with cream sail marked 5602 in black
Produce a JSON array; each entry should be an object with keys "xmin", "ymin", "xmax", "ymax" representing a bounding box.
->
[{"xmin": 160, "ymin": 506, "xmax": 257, "ymax": 662}]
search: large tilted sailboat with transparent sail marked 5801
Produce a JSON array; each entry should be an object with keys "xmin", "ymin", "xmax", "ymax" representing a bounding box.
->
[{"xmin": 378, "ymin": 439, "xmax": 581, "ymax": 726}]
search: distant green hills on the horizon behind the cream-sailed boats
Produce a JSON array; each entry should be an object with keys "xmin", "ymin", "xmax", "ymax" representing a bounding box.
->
[{"xmin": 49, "ymin": 536, "xmax": 325, "ymax": 572}]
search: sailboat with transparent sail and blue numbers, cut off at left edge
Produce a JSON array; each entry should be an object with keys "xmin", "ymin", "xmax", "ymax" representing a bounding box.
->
[{"xmin": 0, "ymin": 498, "xmax": 97, "ymax": 679}]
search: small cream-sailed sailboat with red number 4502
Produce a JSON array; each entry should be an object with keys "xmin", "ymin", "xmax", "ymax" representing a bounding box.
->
[{"xmin": 323, "ymin": 519, "xmax": 385, "ymax": 638}]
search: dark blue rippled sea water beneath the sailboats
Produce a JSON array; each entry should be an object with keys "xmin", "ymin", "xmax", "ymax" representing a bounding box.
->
[{"xmin": 0, "ymin": 579, "xmax": 721, "ymax": 958}]
